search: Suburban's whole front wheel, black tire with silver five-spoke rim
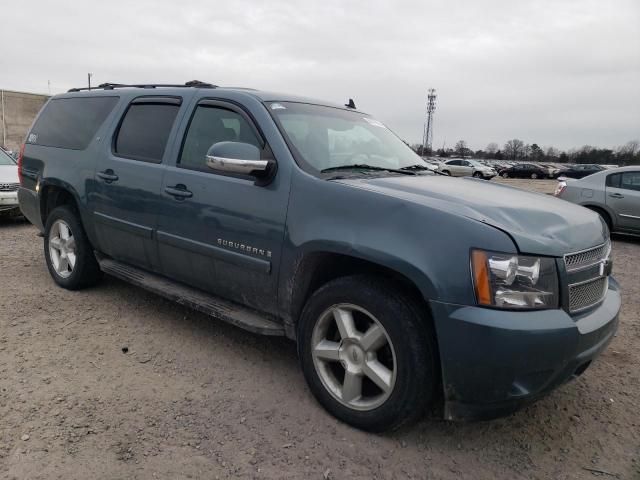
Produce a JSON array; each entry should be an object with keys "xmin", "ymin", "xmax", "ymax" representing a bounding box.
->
[{"xmin": 298, "ymin": 276, "xmax": 438, "ymax": 432}]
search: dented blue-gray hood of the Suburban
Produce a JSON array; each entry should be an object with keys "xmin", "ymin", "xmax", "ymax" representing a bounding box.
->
[{"xmin": 338, "ymin": 175, "xmax": 607, "ymax": 256}]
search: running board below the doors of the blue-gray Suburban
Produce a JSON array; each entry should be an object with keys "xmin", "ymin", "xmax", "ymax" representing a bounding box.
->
[{"xmin": 98, "ymin": 257, "xmax": 284, "ymax": 336}]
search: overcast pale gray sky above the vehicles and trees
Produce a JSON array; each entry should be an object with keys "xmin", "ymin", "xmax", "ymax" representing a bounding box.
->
[{"xmin": 0, "ymin": 0, "xmax": 640, "ymax": 149}]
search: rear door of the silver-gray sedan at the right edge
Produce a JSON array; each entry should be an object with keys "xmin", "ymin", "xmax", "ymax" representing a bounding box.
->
[{"xmin": 606, "ymin": 169, "xmax": 640, "ymax": 232}]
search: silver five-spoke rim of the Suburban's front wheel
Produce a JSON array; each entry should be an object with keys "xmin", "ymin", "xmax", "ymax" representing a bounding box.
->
[{"xmin": 311, "ymin": 304, "xmax": 397, "ymax": 411}]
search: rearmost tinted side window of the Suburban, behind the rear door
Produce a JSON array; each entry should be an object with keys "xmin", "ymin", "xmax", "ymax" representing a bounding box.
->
[{"xmin": 27, "ymin": 97, "xmax": 118, "ymax": 150}]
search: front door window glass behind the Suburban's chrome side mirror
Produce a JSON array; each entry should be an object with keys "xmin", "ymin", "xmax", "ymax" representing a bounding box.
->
[{"xmin": 179, "ymin": 105, "xmax": 263, "ymax": 172}]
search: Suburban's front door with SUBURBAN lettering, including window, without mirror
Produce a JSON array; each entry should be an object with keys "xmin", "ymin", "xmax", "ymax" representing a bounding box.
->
[{"xmin": 157, "ymin": 100, "xmax": 288, "ymax": 311}]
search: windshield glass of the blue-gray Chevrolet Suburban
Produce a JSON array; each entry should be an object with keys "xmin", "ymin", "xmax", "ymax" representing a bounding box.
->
[{"xmin": 269, "ymin": 102, "xmax": 426, "ymax": 173}]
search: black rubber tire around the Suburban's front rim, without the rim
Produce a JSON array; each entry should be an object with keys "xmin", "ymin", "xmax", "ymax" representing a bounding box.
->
[{"xmin": 298, "ymin": 275, "xmax": 439, "ymax": 432}]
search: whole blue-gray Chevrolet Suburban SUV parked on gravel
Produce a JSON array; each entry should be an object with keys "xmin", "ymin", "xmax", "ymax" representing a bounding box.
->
[{"xmin": 18, "ymin": 82, "xmax": 620, "ymax": 431}]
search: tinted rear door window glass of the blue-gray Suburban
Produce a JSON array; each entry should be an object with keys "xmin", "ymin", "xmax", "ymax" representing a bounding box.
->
[{"xmin": 115, "ymin": 103, "xmax": 180, "ymax": 163}]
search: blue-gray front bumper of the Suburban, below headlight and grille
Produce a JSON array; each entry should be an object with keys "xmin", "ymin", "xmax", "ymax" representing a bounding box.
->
[{"xmin": 431, "ymin": 278, "xmax": 620, "ymax": 420}]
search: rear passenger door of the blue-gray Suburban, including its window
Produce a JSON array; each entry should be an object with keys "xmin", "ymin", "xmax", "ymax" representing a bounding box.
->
[{"xmin": 88, "ymin": 96, "xmax": 182, "ymax": 270}]
